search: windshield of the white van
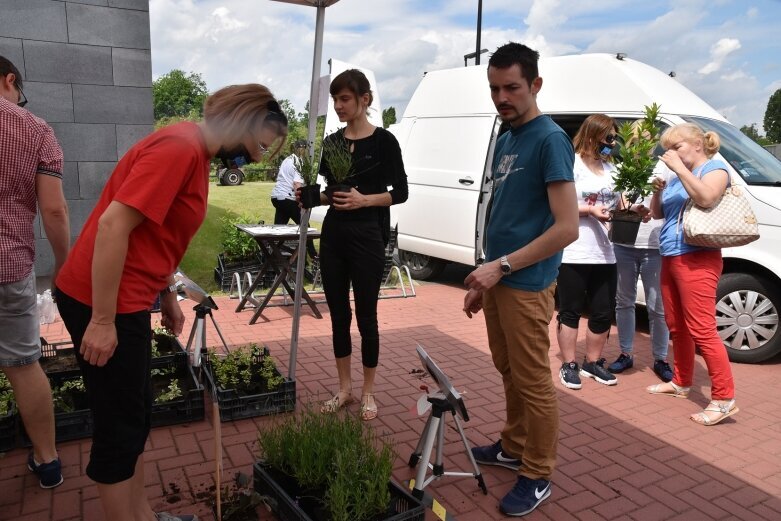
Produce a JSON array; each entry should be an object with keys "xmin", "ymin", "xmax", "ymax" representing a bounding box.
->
[{"xmin": 683, "ymin": 116, "xmax": 781, "ymax": 186}]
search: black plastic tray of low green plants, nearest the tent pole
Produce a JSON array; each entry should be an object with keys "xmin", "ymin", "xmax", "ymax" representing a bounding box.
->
[{"xmin": 203, "ymin": 348, "xmax": 296, "ymax": 421}]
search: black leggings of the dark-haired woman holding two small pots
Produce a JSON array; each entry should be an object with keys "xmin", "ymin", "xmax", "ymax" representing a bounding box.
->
[{"xmin": 320, "ymin": 216, "xmax": 385, "ymax": 368}]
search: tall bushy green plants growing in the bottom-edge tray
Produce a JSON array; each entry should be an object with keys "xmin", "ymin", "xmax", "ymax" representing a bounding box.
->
[{"xmin": 258, "ymin": 409, "xmax": 395, "ymax": 521}]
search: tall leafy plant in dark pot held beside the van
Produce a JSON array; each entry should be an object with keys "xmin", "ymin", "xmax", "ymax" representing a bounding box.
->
[{"xmin": 610, "ymin": 103, "xmax": 660, "ymax": 245}]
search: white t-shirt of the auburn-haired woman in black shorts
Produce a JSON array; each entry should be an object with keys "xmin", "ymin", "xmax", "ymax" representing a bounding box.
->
[{"xmin": 561, "ymin": 154, "xmax": 618, "ymax": 264}]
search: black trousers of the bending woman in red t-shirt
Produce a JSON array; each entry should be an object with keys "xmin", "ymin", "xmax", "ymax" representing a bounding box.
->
[{"xmin": 57, "ymin": 291, "xmax": 152, "ymax": 484}]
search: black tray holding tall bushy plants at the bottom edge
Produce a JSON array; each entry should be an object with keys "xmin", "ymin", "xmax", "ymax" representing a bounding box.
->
[{"xmin": 253, "ymin": 460, "xmax": 426, "ymax": 521}]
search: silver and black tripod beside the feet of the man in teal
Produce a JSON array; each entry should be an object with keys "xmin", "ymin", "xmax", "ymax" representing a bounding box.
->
[{"xmin": 409, "ymin": 392, "xmax": 488, "ymax": 499}]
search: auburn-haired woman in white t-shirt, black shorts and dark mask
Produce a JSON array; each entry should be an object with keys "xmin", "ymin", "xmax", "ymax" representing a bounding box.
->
[{"xmin": 557, "ymin": 114, "xmax": 619, "ymax": 389}]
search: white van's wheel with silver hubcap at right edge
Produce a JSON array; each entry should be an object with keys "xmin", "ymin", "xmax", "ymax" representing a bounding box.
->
[{"xmin": 716, "ymin": 273, "xmax": 781, "ymax": 364}]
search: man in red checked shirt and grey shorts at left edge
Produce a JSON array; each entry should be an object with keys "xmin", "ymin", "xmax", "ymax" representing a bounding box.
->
[{"xmin": 0, "ymin": 56, "xmax": 70, "ymax": 488}]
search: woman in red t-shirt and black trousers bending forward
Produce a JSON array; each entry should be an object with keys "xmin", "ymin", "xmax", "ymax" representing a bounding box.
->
[{"xmin": 56, "ymin": 84, "xmax": 287, "ymax": 521}]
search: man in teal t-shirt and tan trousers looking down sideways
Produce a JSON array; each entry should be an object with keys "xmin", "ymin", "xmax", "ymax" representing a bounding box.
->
[{"xmin": 464, "ymin": 43, "xmax": 578, "ymax": 516}]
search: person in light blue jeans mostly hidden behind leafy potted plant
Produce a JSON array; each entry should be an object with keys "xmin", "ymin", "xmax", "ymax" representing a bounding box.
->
[{"xmin": 607, "ymin": 161, "xmax": 674, "ymax": 382}]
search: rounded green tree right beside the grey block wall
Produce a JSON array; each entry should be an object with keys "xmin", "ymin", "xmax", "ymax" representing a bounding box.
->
[{"xmin": 152, "ymin": 69, "xmax": 209, "ymax": 121}]
